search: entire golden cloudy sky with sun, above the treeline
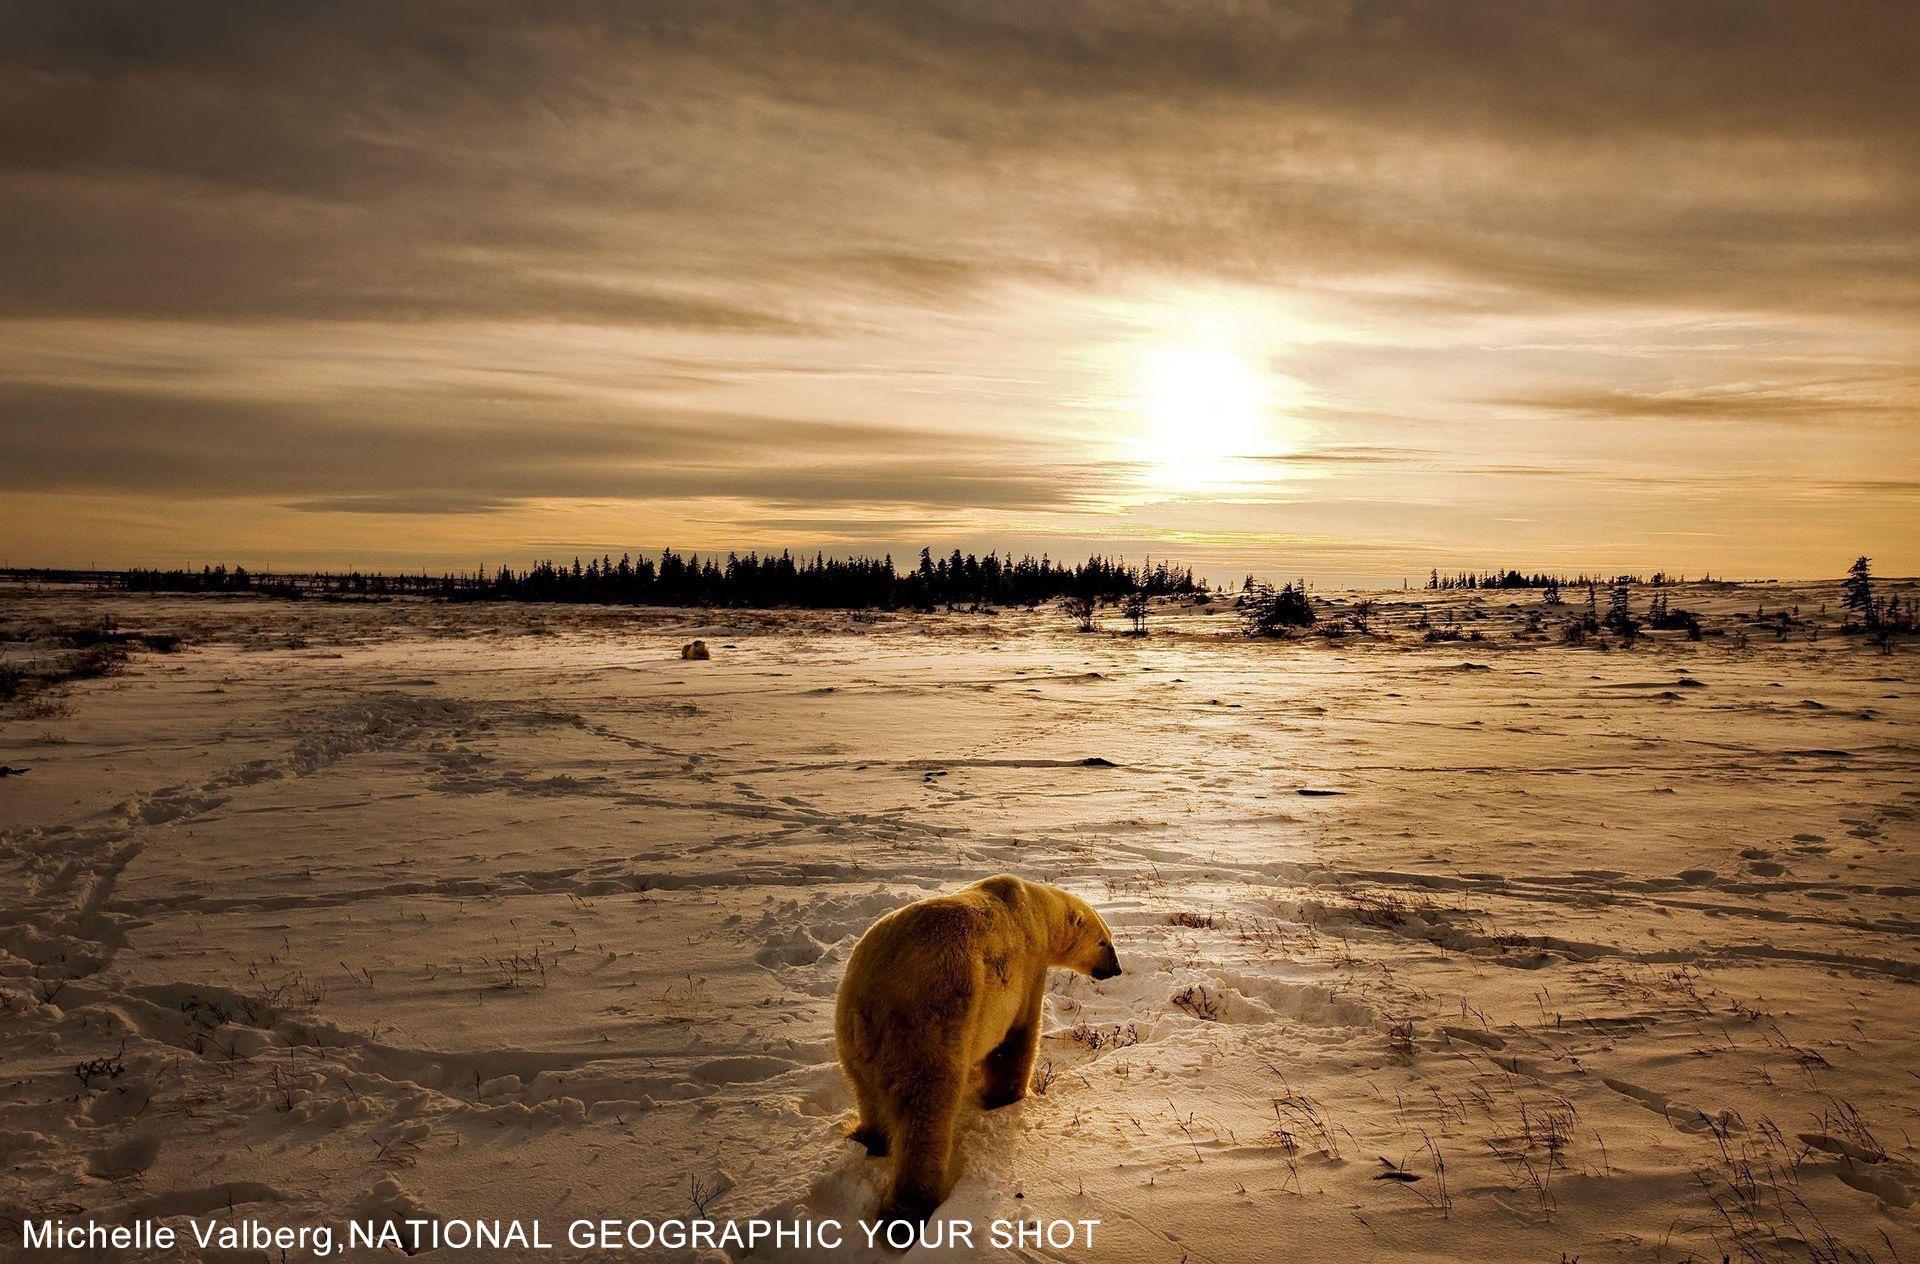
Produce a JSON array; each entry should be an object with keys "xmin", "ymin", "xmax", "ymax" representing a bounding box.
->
[{"xmin": 0, "ymin": 0, "xmax": 1920, "ymax": 584}]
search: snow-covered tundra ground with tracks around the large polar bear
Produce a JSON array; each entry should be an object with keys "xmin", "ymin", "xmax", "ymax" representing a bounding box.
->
[{"xmin": 0, "ymin": 586, "xmax": 1920, "ymax": 1264}]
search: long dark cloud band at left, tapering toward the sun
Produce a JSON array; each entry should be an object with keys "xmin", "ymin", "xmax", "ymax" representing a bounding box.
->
[{"xmin": 0, "ymin": 384, "xmax": 1114, "ymax": 515}]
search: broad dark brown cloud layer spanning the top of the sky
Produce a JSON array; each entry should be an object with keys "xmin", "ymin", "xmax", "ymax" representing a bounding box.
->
[{"xmin": 0, "ymin": 0, "xmax": 1920, "ymax": 328}]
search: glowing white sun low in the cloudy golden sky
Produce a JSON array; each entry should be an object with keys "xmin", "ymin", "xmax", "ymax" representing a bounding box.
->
[{"xmin": 1139, "ymin": 346, "xmax": 1269, "ymax": 492}]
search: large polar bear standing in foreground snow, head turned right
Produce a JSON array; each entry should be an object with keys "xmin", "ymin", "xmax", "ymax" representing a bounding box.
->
[{"xmin": 833, "ymin": 874, "xmax": 1119, "ymax": 1224}]
